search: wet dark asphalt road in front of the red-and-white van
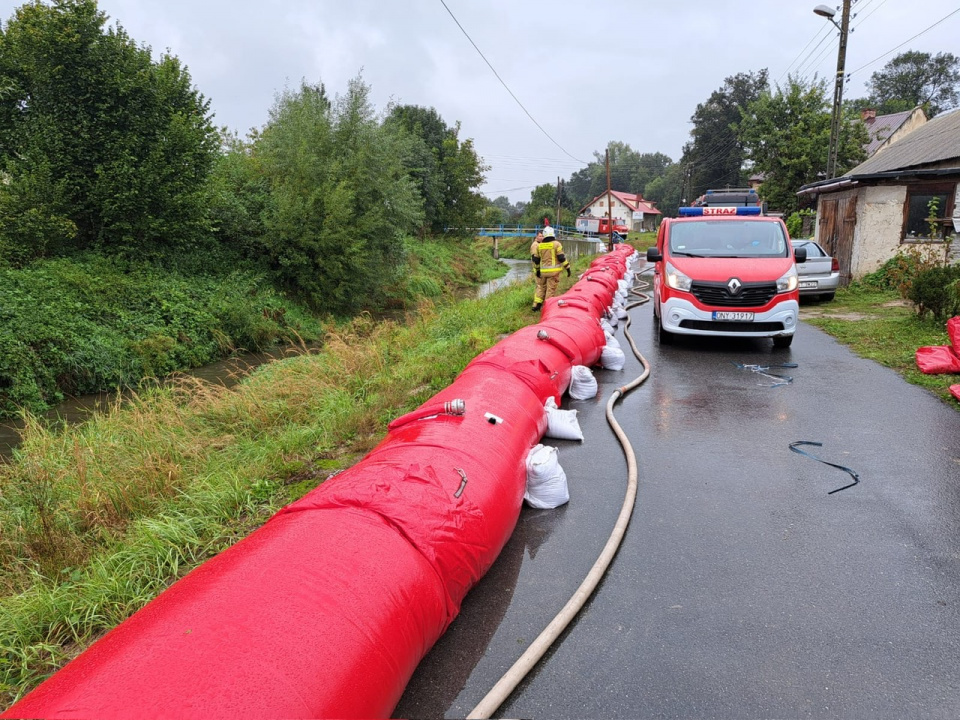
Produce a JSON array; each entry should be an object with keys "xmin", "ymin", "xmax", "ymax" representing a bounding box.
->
[{"xmin": 395, "ymin": 278, "xmax": 960, "ymax": 719}]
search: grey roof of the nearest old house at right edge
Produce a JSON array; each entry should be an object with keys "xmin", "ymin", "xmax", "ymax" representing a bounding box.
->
[{"xmin": 843, "ymin": 110, "xmax": 960, "ymax": 177}]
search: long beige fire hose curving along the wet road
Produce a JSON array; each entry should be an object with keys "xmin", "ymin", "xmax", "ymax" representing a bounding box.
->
[{"xmin": 467, "ymin": 273, "xmax": 650, "ymax": 719}]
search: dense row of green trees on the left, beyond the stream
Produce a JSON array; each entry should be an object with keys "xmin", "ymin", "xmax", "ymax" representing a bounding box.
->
[{"xmin": 0, "ymin": 0, "xmax": 486, "ymax": 314}]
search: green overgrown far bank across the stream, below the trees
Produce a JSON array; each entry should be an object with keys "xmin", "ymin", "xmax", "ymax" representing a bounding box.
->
[{"xmin": 0, "ymin": 240, "xmax": 502, "ymax": 417}]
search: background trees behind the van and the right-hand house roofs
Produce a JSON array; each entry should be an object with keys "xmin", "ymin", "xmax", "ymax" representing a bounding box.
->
[{"xmin": 485, "ymin": 50, "xmax": 960, "ymax": 225}]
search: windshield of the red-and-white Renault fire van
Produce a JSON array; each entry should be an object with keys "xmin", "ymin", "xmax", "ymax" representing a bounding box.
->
[{"xmin": 670, "ymin": 220, "xmax": 787, "ymax": 258}]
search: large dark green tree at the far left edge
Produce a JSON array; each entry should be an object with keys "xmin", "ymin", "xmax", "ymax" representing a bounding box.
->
[{"xmin": 0, "ymin": 0, "xmax": 217, "ymax": 257}]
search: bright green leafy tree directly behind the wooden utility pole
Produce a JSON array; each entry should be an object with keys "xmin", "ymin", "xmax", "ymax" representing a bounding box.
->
[{"xmin": 737, "ymin": 76, "xmax": 867, "ymax": 214}]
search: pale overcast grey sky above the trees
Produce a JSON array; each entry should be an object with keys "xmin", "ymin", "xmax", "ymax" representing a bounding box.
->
[{"xmin": 0, "ymin": 0, "xmax": 960, "ymax": 202}]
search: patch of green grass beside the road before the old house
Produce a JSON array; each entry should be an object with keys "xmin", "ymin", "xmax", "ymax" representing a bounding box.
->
[{"xmin": 801, "ymin": 284, "xmax": 960, "ymax": 410}]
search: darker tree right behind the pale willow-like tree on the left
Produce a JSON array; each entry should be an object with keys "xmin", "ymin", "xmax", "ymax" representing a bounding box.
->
[{"xmin": 388, "ymin": 105, "xmax": 487, "ymax": 233}]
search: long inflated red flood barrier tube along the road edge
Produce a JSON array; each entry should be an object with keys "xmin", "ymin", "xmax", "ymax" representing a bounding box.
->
[{"xmin": 7, "ymin": 246, "xmax": 632, "ymax": 720}]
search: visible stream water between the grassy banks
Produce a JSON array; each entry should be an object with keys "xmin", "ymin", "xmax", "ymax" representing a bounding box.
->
[{"xmin": 0, "ymin": 259, "xmax": 530, "ymax": 460}]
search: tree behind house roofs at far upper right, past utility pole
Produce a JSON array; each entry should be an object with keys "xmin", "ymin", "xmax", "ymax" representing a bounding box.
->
[{"xmin": 867, "ymin": 50, "xmax": 960, "ymax": 117}]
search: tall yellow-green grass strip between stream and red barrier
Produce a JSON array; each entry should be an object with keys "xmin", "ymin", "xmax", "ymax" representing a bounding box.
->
[{"xmin": 0, "ymin": 242, "xmax": 586, "ymax": 705}]
